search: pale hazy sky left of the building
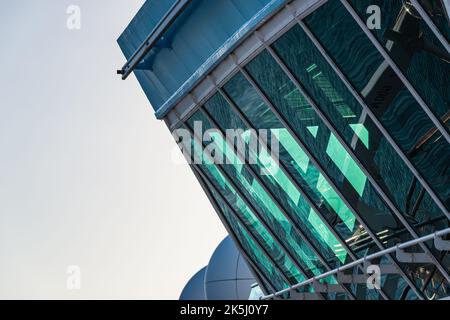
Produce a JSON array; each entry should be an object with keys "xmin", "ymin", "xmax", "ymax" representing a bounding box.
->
[{"xmin": 0, "ymin": 0, "xmax": 226, "ymax": 299}]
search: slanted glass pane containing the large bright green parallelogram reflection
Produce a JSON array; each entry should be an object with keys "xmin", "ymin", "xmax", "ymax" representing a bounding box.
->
[{"xmin": 246, "ymin": 51, "xmax": 412, "ymax": 242}]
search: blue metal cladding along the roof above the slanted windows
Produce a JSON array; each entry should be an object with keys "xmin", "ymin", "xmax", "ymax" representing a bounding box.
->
[{"xmin": 118, "ymin": 0, "xmax": 285, "ymax": 118}]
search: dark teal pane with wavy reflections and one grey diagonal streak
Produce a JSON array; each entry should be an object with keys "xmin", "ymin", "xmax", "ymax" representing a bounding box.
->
[{"xmin": 305, "ymin": 1, "xmax": 450, "ymax": 214}]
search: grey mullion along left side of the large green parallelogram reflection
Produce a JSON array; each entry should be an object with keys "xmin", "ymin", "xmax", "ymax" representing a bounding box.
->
[{"xmin": 235, "ymin": 60, "xmax": 423, "ymax": 299}]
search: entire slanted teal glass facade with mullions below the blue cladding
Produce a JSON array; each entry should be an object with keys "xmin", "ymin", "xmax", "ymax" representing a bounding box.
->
[{"xmin": 122, "ymin": 0, "xmax": 450, "ymax": 299}]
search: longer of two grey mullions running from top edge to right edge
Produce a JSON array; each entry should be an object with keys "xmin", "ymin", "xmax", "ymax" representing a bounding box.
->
[{"xmin": 340, "ymin": 0, "xmax": 450, "ymax": 143}]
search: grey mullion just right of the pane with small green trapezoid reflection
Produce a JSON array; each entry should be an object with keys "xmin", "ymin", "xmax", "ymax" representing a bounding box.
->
[{"xmin": 297, "ymin": 20, "xmax": 450, "ymax": 219}]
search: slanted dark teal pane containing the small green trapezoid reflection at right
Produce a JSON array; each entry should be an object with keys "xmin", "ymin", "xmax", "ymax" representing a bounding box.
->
[{"xmin": 273, "ymin": 25, "xmax": 446, "ymax": 238}]
